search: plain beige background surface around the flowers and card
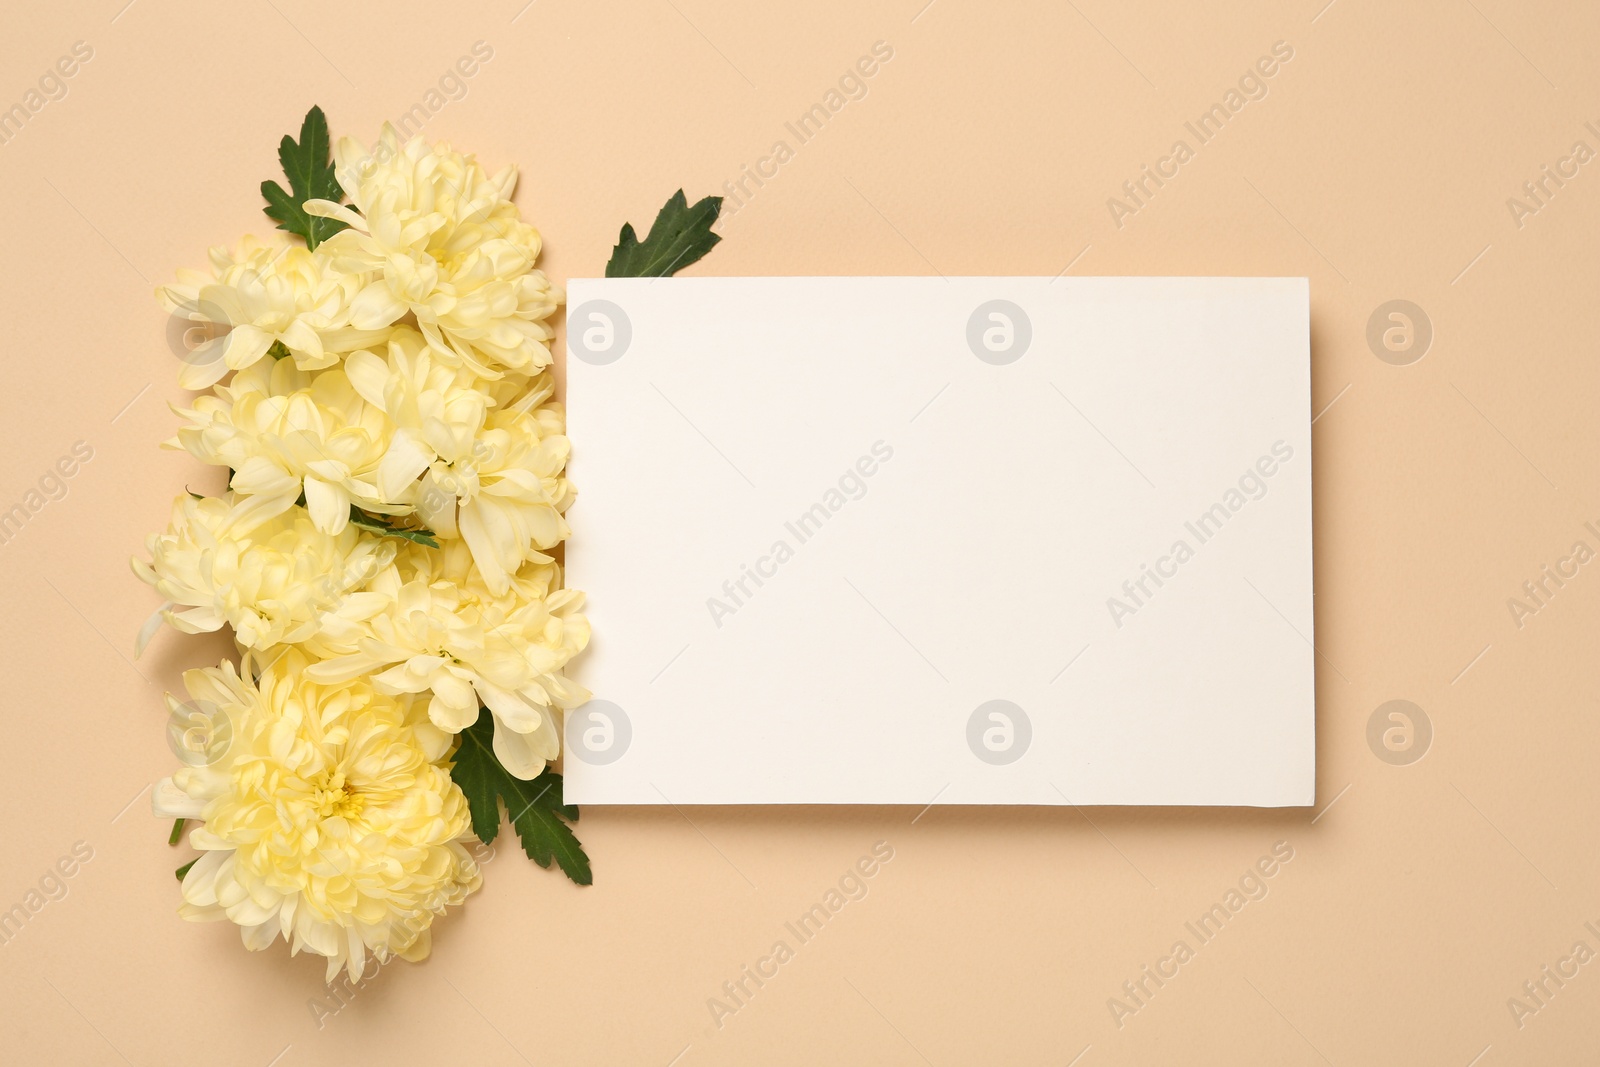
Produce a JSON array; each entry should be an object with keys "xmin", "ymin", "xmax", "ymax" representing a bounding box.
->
[{"xmin": 0, "ymin": 0, "xmax": 1600, "ymax": 1067}]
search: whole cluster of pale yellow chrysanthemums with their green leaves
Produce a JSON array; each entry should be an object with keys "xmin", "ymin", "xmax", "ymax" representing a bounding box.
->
[{"xmin": 133, "ymin": 109, "xmax": 720, "ymax": 981}]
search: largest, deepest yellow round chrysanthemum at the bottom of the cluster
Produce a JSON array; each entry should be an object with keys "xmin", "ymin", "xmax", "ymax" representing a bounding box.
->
[{"xmin": 154, "ymin": 651, "xmax": 482, "ymax": 982}]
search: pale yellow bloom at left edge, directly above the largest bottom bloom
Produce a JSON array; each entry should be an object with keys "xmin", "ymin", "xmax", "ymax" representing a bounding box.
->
[{"xmin": 133, "ymin": 493, "xmax": 397, "ymax": 651}]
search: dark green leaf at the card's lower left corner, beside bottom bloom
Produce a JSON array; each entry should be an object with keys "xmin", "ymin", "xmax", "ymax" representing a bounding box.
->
[{"xmin": 450, "ymin": 709, "xmax": 594, "ymax": 886}]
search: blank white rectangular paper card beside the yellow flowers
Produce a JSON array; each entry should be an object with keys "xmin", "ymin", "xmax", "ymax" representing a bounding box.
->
[{"xmin": 565, "ymin": 277, "xmax": 1315, "ymax": 806}]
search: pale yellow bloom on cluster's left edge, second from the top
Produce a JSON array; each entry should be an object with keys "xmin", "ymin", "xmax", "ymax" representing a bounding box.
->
[{"xmin": 168, "ymin": 360, "xmax": 400, "ymax": 533}]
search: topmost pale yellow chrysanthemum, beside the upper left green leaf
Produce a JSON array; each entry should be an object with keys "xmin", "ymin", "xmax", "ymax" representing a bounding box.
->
[{"xmin": 306, "ymin": 123, "xmax": 565, "ymax": 378}]
